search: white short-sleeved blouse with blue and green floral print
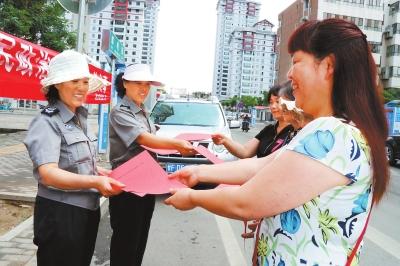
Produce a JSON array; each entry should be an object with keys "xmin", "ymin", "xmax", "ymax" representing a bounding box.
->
[{"xmin": 257, "ymin": 117, "xmax": 372, "ymax": 266}]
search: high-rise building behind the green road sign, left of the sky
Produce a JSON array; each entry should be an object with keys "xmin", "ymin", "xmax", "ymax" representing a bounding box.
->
[{"xmin": 67, "ymin": 0, "xmax": 160, "ymax": 70}]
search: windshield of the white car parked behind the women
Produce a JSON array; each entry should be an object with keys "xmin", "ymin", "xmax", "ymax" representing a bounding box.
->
[{"xmin": 150, "ymin": 102, "xmax": 224, "ymax": 126}]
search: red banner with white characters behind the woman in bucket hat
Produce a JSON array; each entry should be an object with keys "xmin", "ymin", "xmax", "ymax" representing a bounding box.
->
[{"xmin": 0, "ymin": 31, "xmax": 111, "ymax": 104}]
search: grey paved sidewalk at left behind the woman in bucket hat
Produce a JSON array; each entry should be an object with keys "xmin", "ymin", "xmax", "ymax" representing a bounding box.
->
[{"xmin": 0, "ymin": 115, "xmax": 108, "ymax": 266}]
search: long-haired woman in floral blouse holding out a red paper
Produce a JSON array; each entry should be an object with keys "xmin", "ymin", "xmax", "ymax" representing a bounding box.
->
[{"xmin": 166, "ymin": 19, "xmax": 389, "ymax": 266}]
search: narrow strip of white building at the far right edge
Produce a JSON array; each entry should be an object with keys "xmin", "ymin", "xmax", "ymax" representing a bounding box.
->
[{"xmin": 381, "ymin": 0, "xmax": 400, "ymax": 88}]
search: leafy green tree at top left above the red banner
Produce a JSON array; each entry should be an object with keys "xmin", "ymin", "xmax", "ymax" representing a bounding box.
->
[{"xmin": 0, "ymin": 0, "xmax": 77, "ymax": 52}]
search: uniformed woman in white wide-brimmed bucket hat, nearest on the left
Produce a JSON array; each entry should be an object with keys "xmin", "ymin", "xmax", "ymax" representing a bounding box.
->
[{"xmin": 24, "ymin": 51, "xmax": 123, "ymax": 266}]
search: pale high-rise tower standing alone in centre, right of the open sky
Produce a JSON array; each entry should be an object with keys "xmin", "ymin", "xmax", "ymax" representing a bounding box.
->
[{"xmin": 212, "ymin": 0, "xmax": 275, "ymax": 99}]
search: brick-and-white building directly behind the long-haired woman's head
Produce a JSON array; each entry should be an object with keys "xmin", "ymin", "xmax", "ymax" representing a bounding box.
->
[{"xmin": 276, "ymin": 0, "xmax": 384, "ymax": 83}]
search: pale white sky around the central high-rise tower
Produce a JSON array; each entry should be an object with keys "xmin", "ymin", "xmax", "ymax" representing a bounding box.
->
[{"xmin": 154, "ymin": 0, "xmax": 295, "ymax": 92}]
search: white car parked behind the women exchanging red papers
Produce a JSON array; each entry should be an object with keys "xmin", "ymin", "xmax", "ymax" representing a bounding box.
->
[{"xmin": 150, "ymin": 98, "xmax": 235, "ymax": 173}]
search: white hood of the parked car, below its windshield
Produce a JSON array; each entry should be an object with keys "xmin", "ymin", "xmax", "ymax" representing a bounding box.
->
[{"xmin": 156, "ymin": 125, "xmax": 231, "ymax": 138}]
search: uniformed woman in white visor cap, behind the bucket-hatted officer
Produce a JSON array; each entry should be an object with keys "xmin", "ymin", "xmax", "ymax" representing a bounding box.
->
[{"xmin": 109, "ymin": 64, "xmax": 195, "ymax": 266}]
